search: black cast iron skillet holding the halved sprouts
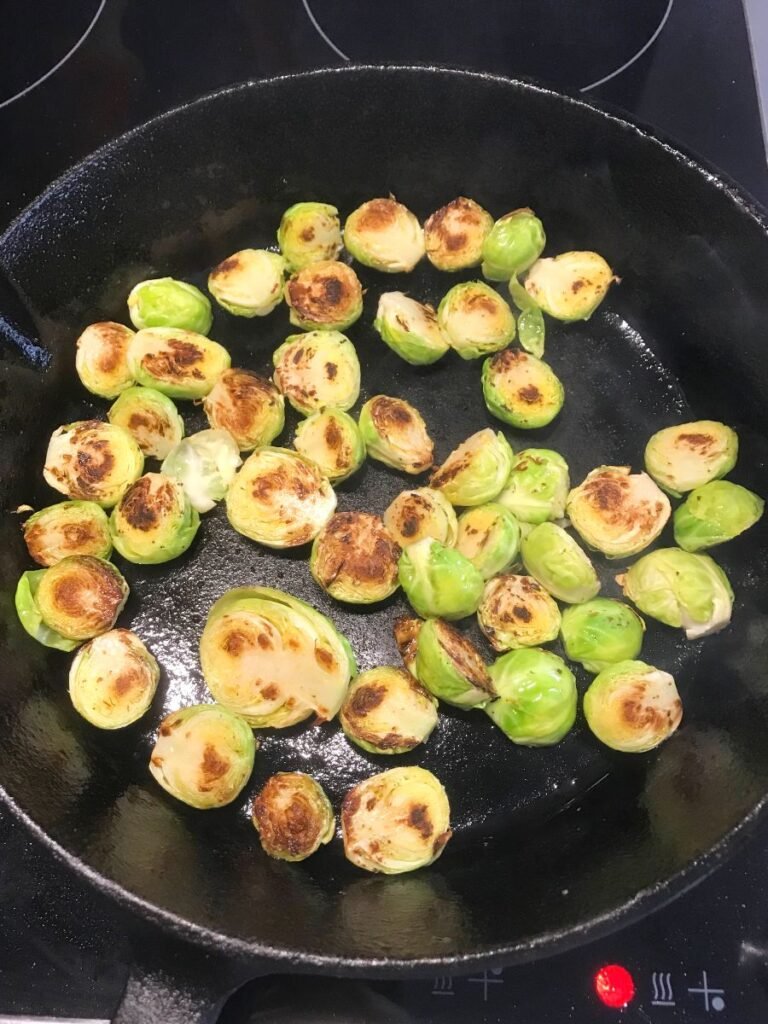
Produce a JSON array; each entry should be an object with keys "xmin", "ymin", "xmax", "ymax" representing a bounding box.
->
[{"xmin": 0, "ymin": 68, "xmax": 768, "ymax": 1022}]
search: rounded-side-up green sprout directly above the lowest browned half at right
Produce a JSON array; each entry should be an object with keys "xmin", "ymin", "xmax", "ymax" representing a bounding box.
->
[{"xmin": 560, "ymin": 597, "xmax": 645, "ymax": 672}]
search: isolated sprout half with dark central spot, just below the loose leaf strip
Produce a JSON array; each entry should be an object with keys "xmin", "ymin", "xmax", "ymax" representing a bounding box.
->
[{"xmin": 482, "ymin": 348, "xmax": 565, "ymax": 430}]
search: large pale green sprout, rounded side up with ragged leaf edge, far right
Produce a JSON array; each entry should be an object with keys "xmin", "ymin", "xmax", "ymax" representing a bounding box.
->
[{"xmin": 616, "ymin": 548, "xmax": 733, "ymax": 640}]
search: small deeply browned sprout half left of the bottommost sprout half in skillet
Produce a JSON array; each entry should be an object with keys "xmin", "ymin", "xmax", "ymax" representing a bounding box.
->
[{"xmin": 252, "ymin": 771, "xmax": 336, "ymax": 861}]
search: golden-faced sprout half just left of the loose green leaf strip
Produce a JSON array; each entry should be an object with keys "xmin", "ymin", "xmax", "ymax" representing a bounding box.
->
[{"xmin": 437, "ymin": 281, "xmax": 515, "ymax": 359}]
